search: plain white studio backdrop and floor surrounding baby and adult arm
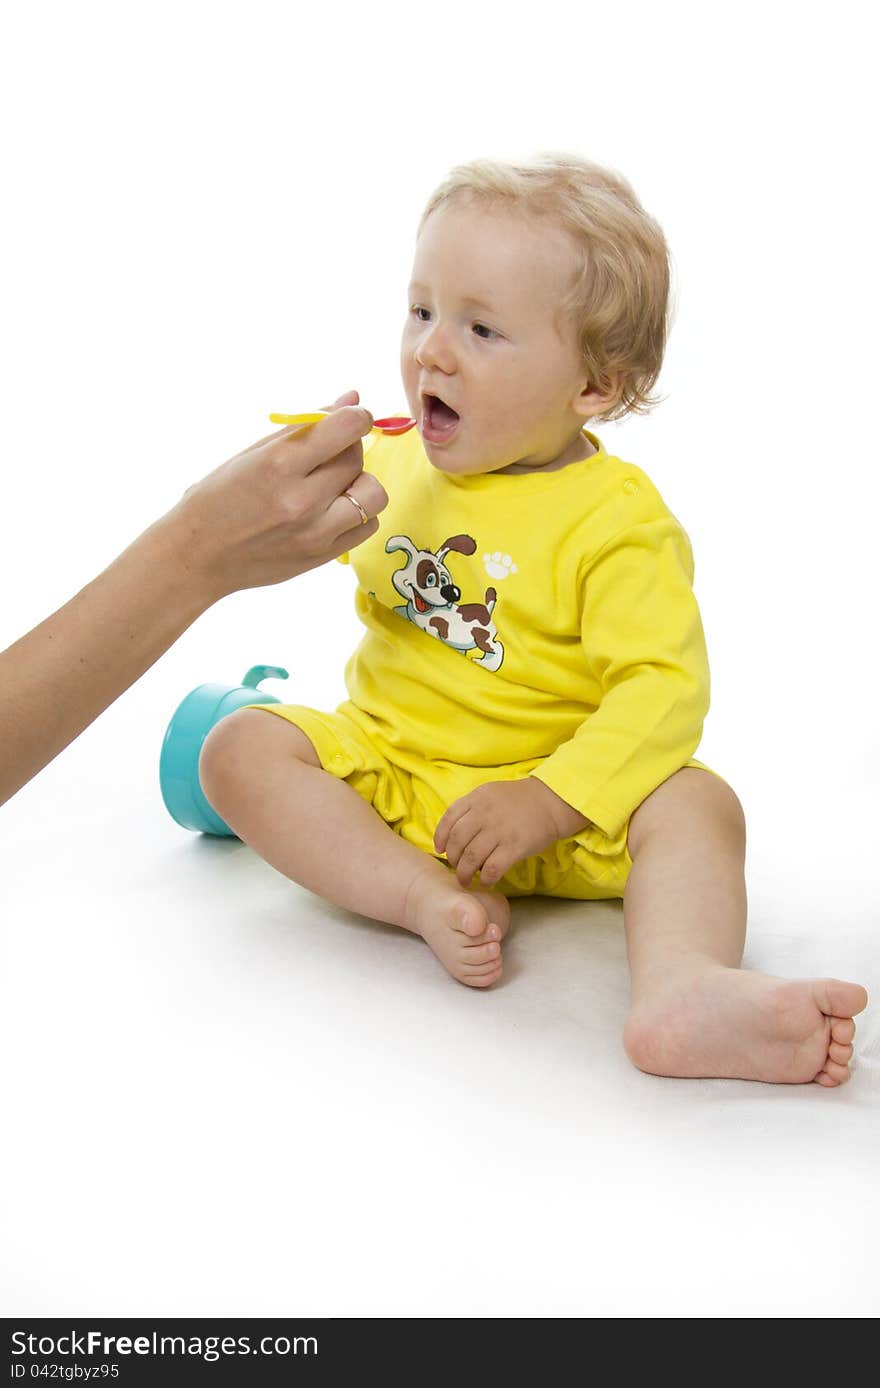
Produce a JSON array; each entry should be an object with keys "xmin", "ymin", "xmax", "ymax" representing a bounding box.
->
[{"xmin": 0, "ymin": 0, "xmax": 880, "ymax": 1317}]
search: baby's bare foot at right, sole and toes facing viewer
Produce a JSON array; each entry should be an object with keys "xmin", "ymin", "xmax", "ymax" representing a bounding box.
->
[{"xmin": 623, "ymin": 965, "xmax": 868, "ymax": 1087}]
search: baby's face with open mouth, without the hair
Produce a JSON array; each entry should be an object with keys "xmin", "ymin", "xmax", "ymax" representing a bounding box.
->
[{"xmin": 401, "ymin": 204, "xmax": 601, "ymax": 475}]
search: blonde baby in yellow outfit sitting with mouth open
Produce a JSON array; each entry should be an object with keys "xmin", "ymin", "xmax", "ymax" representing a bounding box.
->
[{"xmin": 200, "ymin": 154, "xmax": 868, "ymax": 1087}]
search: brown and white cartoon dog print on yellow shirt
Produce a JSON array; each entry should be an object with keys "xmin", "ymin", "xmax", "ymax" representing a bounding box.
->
[{"xmin": 384, "ymin": 534, "xmax": 504, "ymax": 670}]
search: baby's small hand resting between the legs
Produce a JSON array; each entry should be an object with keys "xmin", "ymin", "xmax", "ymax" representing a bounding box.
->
[{"xmin": 434, "ymin": 776, "xmax": 590, "ymax": 887}]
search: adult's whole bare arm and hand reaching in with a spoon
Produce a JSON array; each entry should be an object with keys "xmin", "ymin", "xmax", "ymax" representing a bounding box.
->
[{"xmin": 0, "ymin": 390, "xmax": 389, "ymax": 805}]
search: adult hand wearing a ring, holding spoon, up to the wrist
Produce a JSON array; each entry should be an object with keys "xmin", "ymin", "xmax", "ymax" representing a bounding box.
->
[{"xmin": 164, "ymin": 390, "xmax": 389, "ymax": 601}]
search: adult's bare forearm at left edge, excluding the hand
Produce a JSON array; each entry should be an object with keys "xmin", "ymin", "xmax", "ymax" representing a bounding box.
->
[{"xmin": 0, "ymin": 512, "xmax": 212, "ymax": 804}]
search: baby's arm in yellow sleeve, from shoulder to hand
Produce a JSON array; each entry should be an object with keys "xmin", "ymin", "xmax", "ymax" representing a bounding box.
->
[{"xmin": 434, "ymin": 509, "xmax": 708, "ymax": 884}]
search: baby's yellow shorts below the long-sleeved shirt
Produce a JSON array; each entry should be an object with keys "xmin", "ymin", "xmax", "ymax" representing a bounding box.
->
[{"xmin": 248, "ymin": 702, "xmax": 709, "ymax": 901}]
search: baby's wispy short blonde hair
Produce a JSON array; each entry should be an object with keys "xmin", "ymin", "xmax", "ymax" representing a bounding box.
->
[{"xmin": 418, "ymin": 153, "xmax": 670, "ymax": 419}]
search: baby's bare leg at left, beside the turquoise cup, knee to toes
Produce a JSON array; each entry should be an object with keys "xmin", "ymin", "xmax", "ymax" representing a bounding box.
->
[{"xmin": 198, "ymin": 709, "xmax": 511, "ymax": 988}]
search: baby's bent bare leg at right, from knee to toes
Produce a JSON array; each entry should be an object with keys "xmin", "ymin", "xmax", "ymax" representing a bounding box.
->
[{"xmin": 623, "ymin": 768, "xmax": 868, "ymax": 1085}]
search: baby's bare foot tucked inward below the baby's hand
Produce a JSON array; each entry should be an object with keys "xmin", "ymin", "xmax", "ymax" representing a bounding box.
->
[{"xmin": 407, "ymin": 863, "xmax": 511, "ymax": 988}]
